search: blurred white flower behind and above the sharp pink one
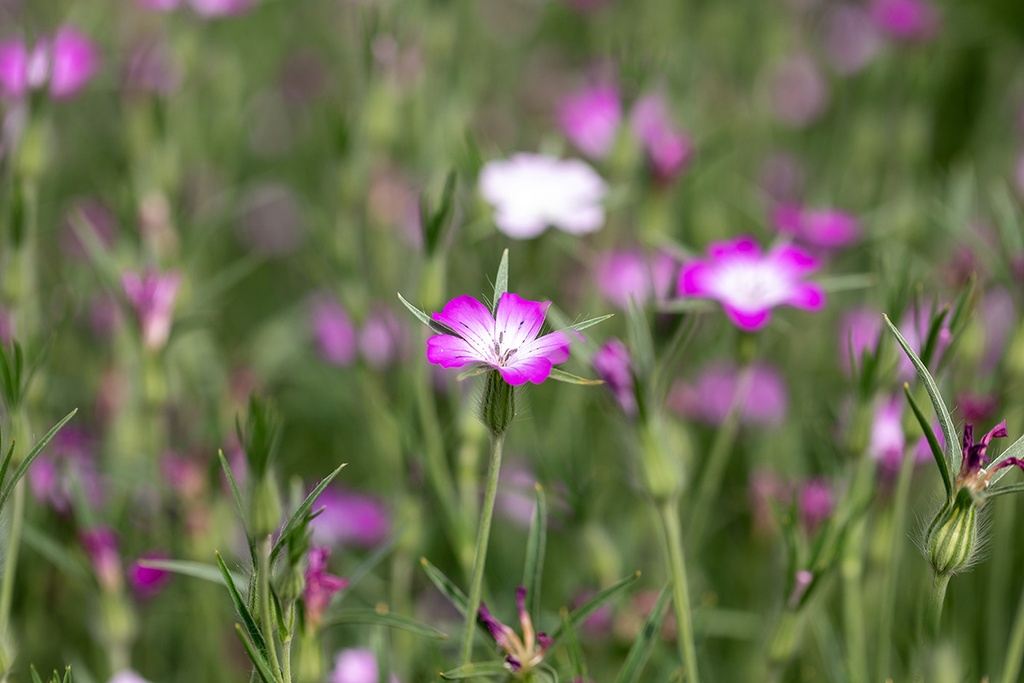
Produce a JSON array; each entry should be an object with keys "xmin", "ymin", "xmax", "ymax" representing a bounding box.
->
[{"xmin": 480, "ymin": 154, "xmax": 607, "ymax": 240}]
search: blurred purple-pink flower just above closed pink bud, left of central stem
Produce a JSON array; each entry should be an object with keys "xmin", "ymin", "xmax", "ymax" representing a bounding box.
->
[{"xmin": 309, "ymin": 486, "xmax": 391, "ymax": 548}]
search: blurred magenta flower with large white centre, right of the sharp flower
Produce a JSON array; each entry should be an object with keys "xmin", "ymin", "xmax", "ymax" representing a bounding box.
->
[{"xmin": 679, "ymin": 238, "xmax": 825, "ymax": 332}]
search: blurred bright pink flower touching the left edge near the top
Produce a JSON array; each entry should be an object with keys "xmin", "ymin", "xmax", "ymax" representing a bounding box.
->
[{"xmin": 0, "ymin": 27, "xmax": 99, "ymax": 99}]
